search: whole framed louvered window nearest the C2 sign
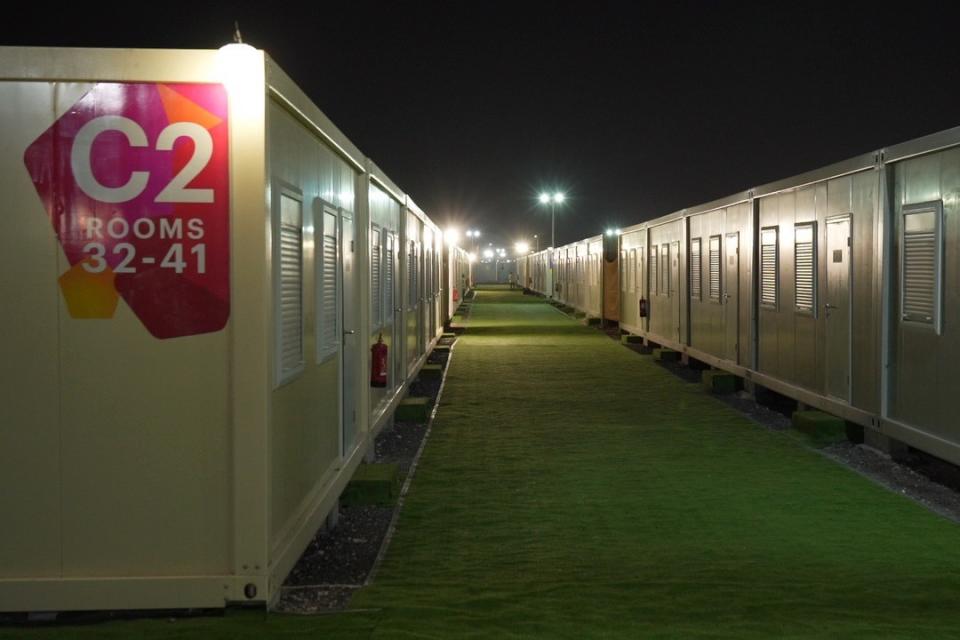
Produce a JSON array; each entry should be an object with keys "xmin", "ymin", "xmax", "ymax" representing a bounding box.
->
[{"xmin": 275, "ymin": 194, "xmax": 303, "ymax": 384}]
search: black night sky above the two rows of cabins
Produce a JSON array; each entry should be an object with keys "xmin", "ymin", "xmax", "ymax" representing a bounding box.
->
[{"xmin": 7, "ymin": 1, "xmax": 960, "ymax": 247}]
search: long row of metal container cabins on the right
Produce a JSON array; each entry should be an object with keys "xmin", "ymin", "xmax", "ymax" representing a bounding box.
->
[{"xmin": 519, "ymin": 128, "xmax": 960, "ymax": 476}]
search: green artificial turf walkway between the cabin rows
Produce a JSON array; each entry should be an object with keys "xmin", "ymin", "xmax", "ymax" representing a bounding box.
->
[{"xmin": 11, "ymin": 289, "xmax": 960, "ymax": 639}]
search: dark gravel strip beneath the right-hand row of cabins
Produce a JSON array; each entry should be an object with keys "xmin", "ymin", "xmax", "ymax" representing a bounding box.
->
[{"xmin": 603, "ymin": 327, "xmax": 960, "ymax": 522}]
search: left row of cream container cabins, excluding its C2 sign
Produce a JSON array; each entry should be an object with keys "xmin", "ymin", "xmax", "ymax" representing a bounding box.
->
[{"xmin": 0, "ymin": 45, "xmax": 470, "ymax": 611}]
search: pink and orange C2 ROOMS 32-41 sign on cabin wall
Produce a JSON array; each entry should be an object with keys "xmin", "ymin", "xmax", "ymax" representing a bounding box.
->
[{"xmin": 24, "ymin": 83, "xmax": 230, "ymax": 339}]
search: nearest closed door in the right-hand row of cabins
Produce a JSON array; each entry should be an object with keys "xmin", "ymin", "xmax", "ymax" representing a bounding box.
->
[{"xmin": 823, "ymin": 218, "xmax": 852, "ymax": 400}]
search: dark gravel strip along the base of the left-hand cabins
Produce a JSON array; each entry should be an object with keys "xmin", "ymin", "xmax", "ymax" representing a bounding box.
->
[{"xmin": 275, "ymin": 328, "xmax": 455, "ymax": 615}]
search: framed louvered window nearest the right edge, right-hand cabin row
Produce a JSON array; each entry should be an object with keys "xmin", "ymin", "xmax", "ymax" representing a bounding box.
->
[{"xmin": 900, "ymin": 201, "xmax": 943, "ymax": 332}]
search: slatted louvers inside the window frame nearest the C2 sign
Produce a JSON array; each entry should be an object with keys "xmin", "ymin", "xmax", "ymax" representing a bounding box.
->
[{"xmin": 280, "ymin": 224, "xmax": 303, "ymax": 376}]
